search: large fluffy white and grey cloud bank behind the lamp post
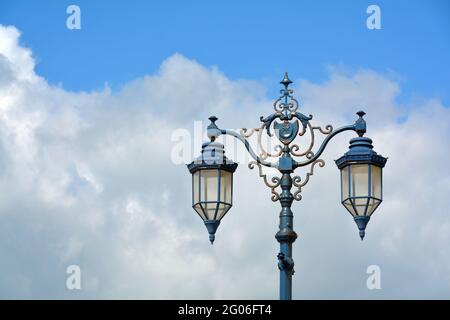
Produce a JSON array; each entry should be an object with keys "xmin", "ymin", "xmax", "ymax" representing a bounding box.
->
[{"xmin": 0, "ymin": 26, "xmax": 450, "ymax": 299}]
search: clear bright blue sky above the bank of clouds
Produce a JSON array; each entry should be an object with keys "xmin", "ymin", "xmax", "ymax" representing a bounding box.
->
[{"xmin": 0, "ymin": 0, "xmax": 450, "ymax": 104}]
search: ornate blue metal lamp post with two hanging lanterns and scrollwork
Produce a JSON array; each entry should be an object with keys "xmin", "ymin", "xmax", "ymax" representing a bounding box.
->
[{"xmin": 188, "ymin": 73, "xmax": 387, "ymax": 300}]
